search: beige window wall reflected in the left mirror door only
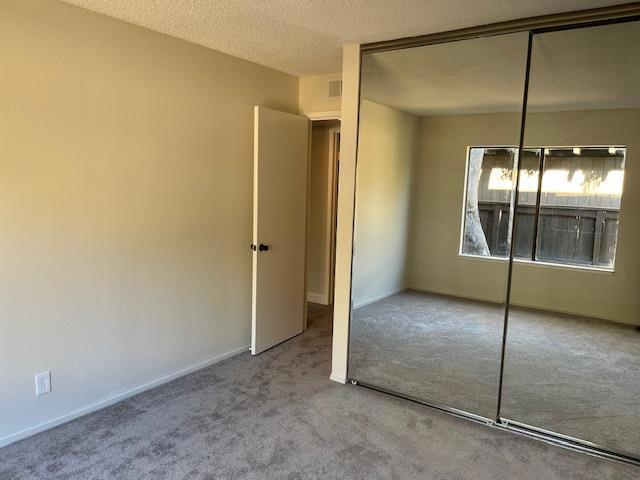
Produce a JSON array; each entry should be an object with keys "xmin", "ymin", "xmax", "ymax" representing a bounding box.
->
[{"xmin": 408, "ymin": 114, "xmax": 520, "ymax": 301}]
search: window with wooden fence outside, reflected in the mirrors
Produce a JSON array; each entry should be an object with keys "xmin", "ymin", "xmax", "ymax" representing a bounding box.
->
[{"xmin": 460, "ymin": 146, "xmax": 626, "ymax": 269}]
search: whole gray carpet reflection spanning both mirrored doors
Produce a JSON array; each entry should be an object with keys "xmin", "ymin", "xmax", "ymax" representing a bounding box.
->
[{"xmin": 349, "ymin": 290, "xmax": 640, "ymax": 457}]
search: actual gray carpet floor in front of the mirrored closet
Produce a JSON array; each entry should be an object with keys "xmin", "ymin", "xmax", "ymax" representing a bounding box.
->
[{"xmin": 0, "ymin": 311, "xmax": 640, "ymax": 480}]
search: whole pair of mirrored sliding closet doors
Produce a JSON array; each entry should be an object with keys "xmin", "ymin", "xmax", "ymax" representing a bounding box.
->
[{"xmin": 348, "ymin": 8, "xmax": 640, "ymax": 463}]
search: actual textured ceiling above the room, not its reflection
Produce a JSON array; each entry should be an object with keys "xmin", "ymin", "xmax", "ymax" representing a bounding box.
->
[{"xmin": 64, "ymin": 0, "xmax": 630, "ymax": 75}]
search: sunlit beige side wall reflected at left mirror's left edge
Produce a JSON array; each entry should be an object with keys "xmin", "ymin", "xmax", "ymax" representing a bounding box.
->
[{"xmin": 352, "ymin": 100, "xmax": 419, "ymax": 308}]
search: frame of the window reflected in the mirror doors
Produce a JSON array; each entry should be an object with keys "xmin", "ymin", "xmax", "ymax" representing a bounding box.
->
[{"xmin": 458, "ymin": 145, "xmax": 628, "ymax": 274}]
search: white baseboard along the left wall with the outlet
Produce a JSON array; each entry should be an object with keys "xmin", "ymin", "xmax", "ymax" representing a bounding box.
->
[{"xmin": 0, "ymin": 345, "xmax": 250, "ymax": 448}]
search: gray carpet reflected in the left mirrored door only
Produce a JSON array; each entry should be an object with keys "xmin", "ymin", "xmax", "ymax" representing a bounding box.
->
[{"xmin": 349, "ymin": 290, "xmax": 504, "ymax": 419}]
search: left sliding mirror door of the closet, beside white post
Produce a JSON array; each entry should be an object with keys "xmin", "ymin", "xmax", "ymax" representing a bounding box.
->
[{"xmin": 348, "ymin": 33, "xmax": 538, "ymax": 419}]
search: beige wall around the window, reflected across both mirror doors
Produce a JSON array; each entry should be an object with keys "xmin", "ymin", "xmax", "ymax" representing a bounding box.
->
[{"xmin": 409, "ymin": 110, "xmax": 640, "ymax": 324}]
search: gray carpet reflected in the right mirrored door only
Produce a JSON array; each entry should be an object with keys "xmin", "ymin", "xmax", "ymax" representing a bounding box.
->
[{"xmin": 502, "ymin": 309, "xmax": 640, "ymax": 457}]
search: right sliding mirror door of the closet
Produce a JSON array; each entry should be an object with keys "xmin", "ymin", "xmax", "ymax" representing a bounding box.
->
[{"xmin": 500, "ymin": 22, "xmax": 640, "ymax": 458}]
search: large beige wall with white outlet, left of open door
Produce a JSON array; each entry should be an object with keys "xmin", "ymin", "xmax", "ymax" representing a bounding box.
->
[{"xmin": 0, "ymin": 0, "xmax": 298, "ymax": 443}]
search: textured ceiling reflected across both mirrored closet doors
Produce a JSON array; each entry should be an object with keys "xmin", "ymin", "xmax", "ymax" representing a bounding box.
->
[{"xmin": 362, "ymin": 22, "xmax": 640, "ymax": 115}]
